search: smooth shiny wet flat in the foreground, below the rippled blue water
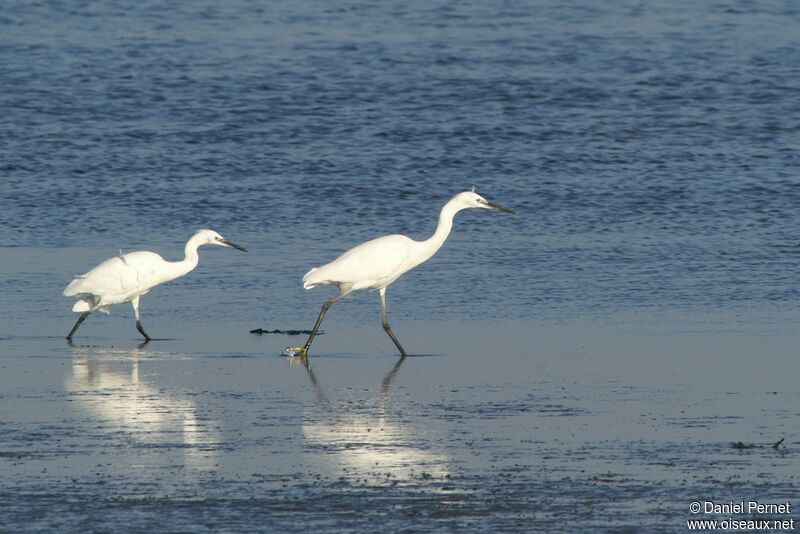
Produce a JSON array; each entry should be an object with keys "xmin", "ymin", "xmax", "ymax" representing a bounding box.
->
[{"xmin": 0, "ymin": 317, "xmax": 800, "ymax": 532}]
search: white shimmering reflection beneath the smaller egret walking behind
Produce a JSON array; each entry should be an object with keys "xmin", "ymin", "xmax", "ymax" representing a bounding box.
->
[{"xmin": 66, "ymin": 347, "xmax": 220, "ymax": 469}]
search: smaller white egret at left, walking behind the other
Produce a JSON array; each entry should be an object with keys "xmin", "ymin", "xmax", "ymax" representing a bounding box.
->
[{"xmin": 64, "ymin": 230, "xmax": 247, "ymax": 343}]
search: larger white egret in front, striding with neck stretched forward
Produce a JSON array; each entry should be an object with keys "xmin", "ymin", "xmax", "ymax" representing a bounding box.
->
[{"xmin": 287, "ymin": 191, "xmax": 517, "ymax": 357}]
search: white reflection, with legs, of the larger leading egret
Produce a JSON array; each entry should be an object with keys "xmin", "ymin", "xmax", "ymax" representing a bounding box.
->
[{"xmin": 297, "ymin": 357, "xmax": 450, "ymax": 484}]
